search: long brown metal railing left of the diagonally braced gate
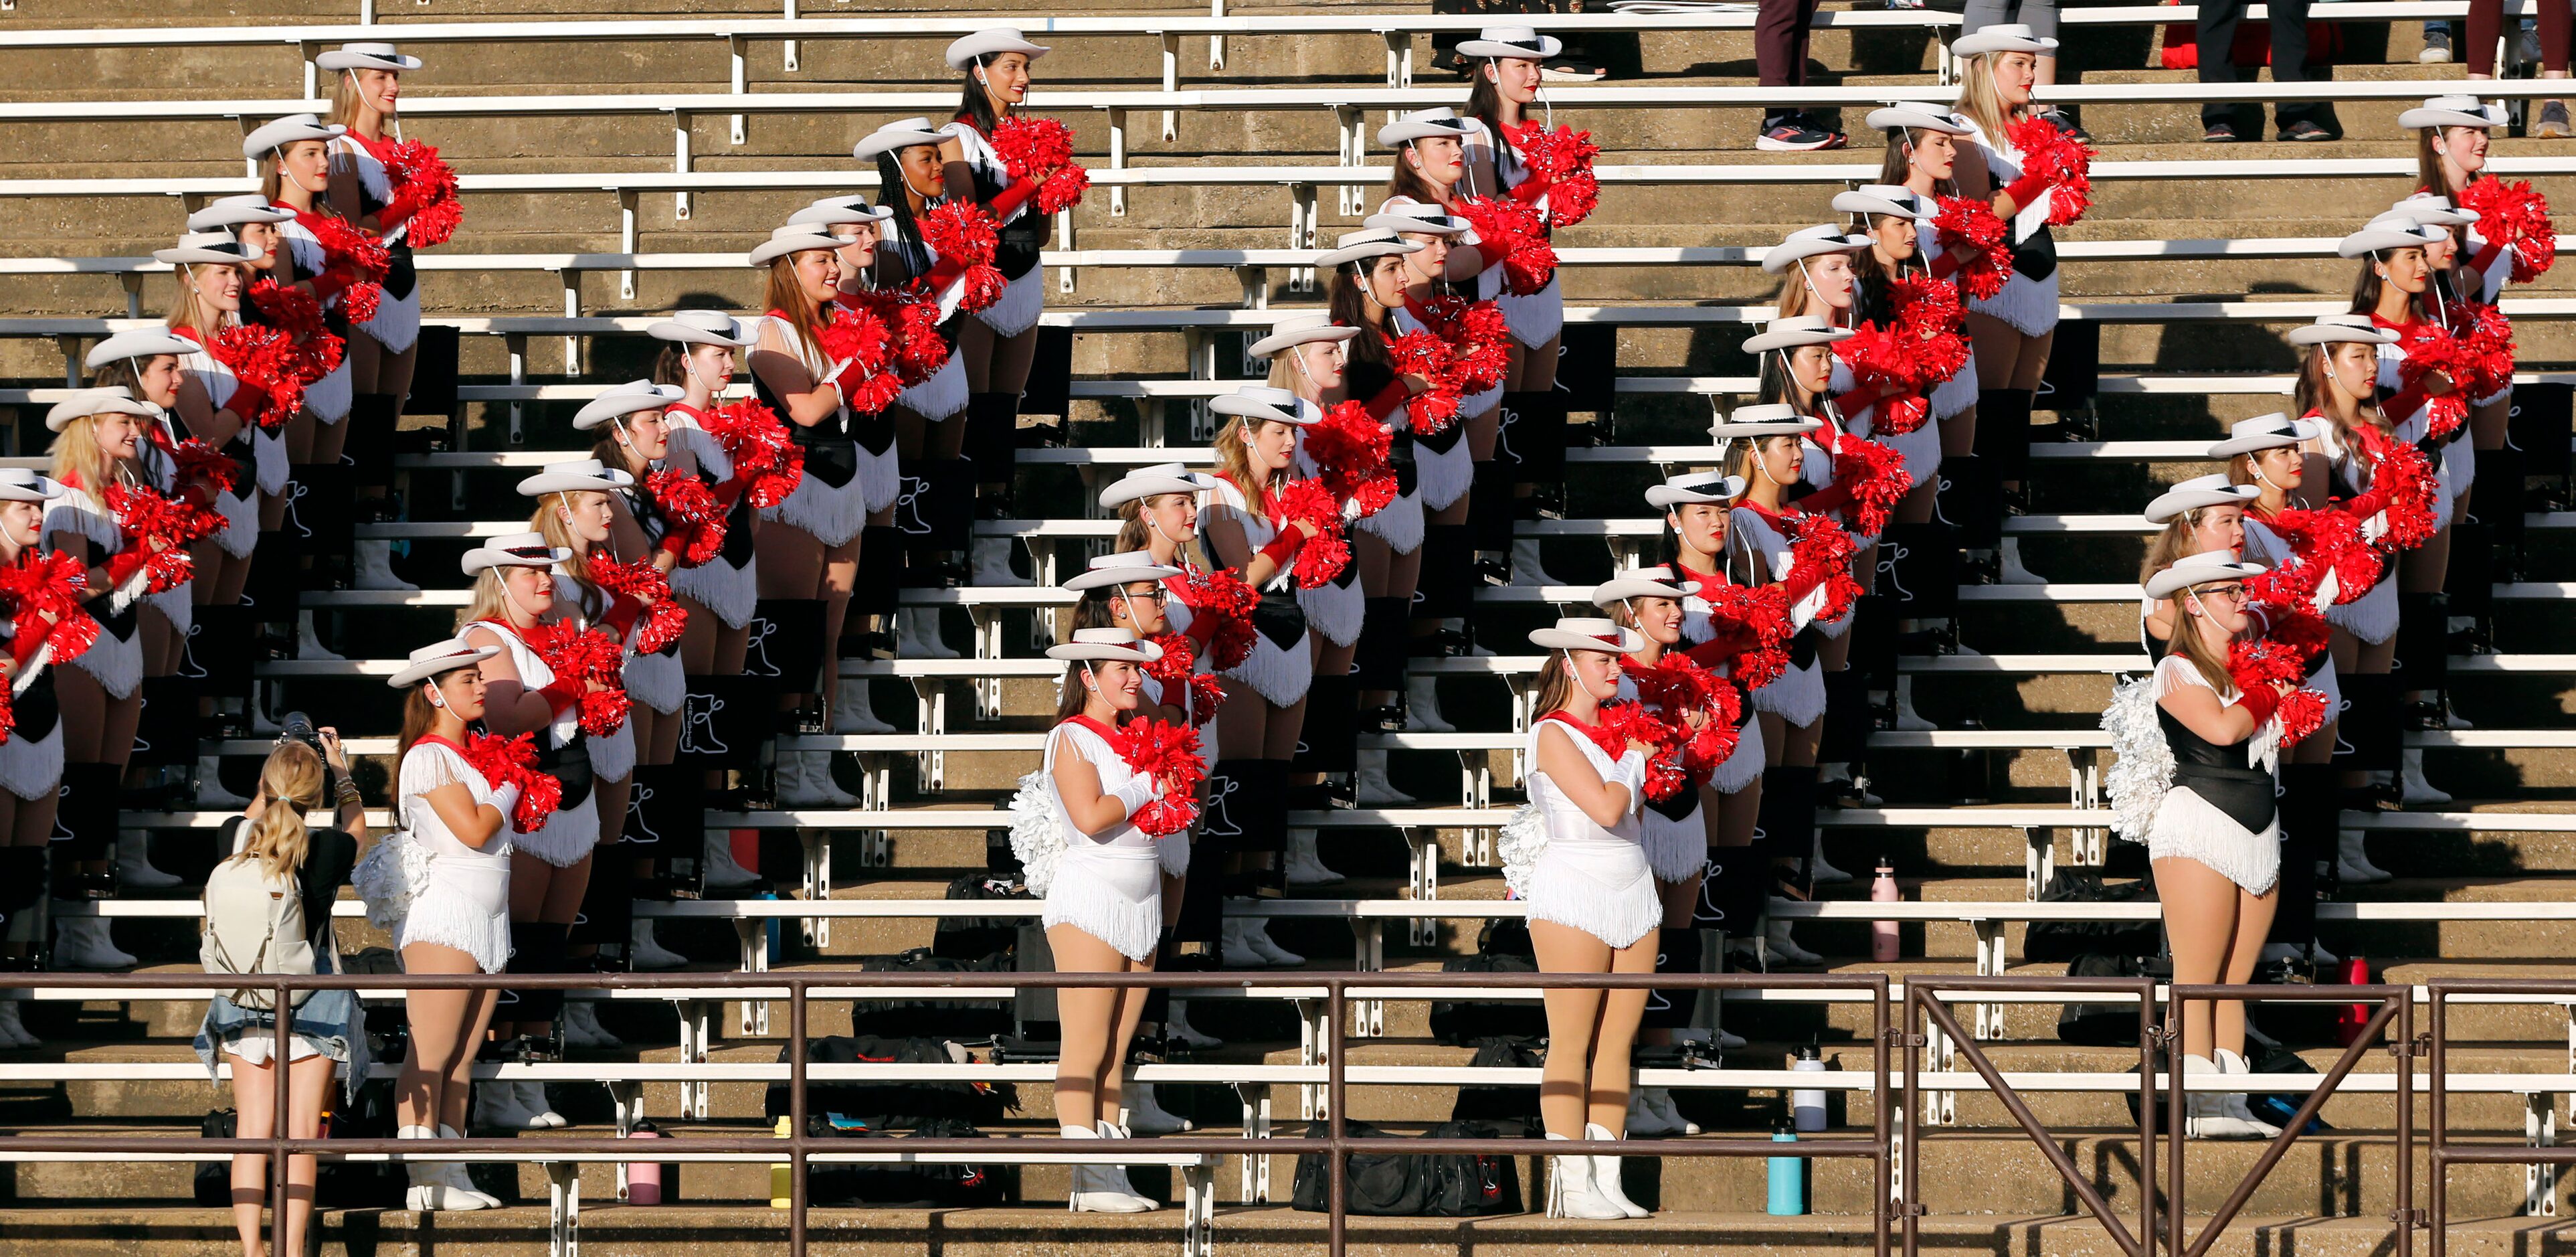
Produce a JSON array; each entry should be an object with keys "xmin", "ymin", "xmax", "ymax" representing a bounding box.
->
[{"xmin": 8, "ymin": 971, "xmax": 1896, "ymax": 1257}]
